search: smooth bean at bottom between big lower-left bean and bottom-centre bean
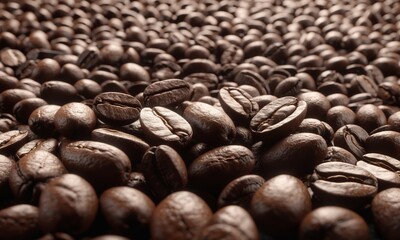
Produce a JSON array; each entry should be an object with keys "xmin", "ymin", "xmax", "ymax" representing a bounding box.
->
[{"xmin": 99, "ymin": 187, "xmax": 155, "ymax": 238}]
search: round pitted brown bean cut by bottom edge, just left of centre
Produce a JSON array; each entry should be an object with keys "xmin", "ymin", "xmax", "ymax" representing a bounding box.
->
[{"xmin": 150, "ymin": 191, "xmax": 212, "ymax": 240}]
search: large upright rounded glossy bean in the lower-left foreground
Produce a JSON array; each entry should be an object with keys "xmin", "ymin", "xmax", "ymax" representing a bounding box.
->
[{"xmin": 39, "ymin": 174, "xmax": 98, "ymax": 234}]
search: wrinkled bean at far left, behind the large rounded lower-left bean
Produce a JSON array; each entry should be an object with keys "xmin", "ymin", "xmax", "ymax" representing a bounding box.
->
[{"xmin": 9, "ymin": 150, "xmax": 67, "ymax": 203}]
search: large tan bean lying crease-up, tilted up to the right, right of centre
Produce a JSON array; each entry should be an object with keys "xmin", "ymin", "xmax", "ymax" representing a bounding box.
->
[{"xmin": 250, "ymin": 97, "xmax": 307, "ymax": 142}]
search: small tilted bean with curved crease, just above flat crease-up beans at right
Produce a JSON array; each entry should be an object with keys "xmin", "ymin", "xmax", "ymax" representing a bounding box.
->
[{"xmin": 333, "ymin": 124, "xmax": 369, "ymax": 159}]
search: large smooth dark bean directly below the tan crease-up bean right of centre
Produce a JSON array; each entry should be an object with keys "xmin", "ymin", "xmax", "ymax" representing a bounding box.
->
[{"xmin": 258, "ymin": 133, "xmax": 327, "ymax": 178}]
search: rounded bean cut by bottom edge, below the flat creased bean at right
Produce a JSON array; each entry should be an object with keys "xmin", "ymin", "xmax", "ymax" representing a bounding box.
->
[{"xmin": 299, "ymin": 206, "xmax": 370, "ymax": 240}]
